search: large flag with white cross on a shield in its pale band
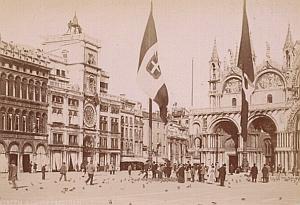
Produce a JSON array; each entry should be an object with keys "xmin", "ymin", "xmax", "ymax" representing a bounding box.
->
[{"xmin": 137, "ymin": 3, "xmax": 169, "ymax": 123}]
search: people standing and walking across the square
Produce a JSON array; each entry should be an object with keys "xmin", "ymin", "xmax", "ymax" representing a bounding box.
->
[{"xmin": 8, "ymin": 161, "xmax": 299, "ymax": 188}]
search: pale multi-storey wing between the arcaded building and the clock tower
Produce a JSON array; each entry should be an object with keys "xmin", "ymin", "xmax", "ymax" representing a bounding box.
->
[{"xmin": 48, "ymin": 55, "xmax": 84, "ymax": 171}]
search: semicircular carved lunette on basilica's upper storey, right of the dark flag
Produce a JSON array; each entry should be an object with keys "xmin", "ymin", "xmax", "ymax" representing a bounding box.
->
[{"xmin": 256, "ymin": 73, "xmax": 284, "ymax": 89}]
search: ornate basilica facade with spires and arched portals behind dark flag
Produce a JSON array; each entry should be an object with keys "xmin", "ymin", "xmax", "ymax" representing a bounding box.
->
[{"xmin": 189, "ymin": 26, "xmax": 300, "ymax": 171}]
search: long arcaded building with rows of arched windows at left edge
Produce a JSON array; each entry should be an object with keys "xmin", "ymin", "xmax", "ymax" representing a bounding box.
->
[{"xmin": 0, "ymin": 41, "xmax": 50, "ymax": 172}]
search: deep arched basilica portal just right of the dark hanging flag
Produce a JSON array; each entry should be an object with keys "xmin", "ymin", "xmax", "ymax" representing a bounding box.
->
[{"xmin": 247, "ymin": 115, "xmax": 277, "ymax": 168}]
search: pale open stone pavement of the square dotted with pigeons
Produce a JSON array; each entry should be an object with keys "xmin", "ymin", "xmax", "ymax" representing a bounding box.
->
[{"xmin": 0, "ymin": 172, "xmax": 300, "ymax": 205}]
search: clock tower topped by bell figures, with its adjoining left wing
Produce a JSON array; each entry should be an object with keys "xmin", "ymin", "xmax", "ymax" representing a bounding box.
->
[{"xmin": 43, "ymin": 15, "xmax": 117, "ymax": 170}]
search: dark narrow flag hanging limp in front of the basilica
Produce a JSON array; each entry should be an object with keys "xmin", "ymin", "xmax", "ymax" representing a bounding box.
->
[{"xmin": 238, "ymin": 0, "xmax": 254, "ymax": 141}]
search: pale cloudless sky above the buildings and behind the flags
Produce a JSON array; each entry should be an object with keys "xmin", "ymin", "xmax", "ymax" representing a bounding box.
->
[{"xmin": 0, "ymin": 0, "xmax": 300, "ymax": 110}]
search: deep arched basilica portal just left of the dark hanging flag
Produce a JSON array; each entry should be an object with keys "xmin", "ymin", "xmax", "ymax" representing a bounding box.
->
[{"xmin": 212, "ymin": 119, "xmax": 239, "ymax": 170}]
